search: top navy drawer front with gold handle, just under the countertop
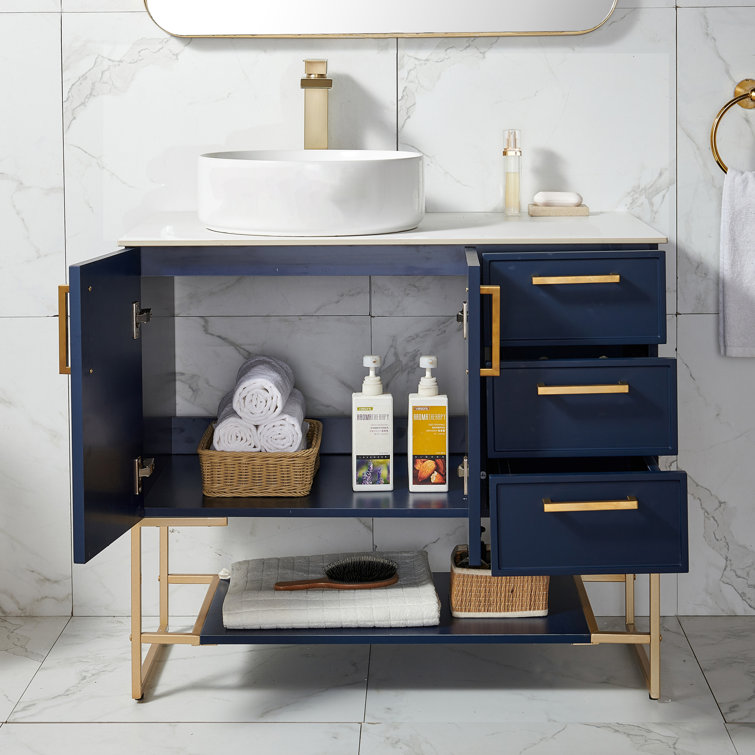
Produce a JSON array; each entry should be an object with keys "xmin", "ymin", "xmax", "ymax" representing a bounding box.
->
[{"xmin": 485, "ymin": 252, "xmax": 666, "ymax": 346}]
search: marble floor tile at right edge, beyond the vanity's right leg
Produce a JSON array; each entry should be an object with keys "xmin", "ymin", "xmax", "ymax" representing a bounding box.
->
[{"xmin": 680, "ymin": 616, "xmax": 755, "ymax": 724}]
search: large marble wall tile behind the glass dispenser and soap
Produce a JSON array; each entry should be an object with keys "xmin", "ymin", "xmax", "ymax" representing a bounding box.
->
[{"xmin": 398, "ymin": 8, "xmax": 676, "ymax": 312}]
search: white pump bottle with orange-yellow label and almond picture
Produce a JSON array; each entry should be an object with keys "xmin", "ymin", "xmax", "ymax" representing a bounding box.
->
[{"xmin": 407, "ymin": 356, "xmax": 448, "ymax": 493}]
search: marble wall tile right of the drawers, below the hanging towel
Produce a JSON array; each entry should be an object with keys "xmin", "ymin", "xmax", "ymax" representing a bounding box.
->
[{"xmin": 677, "ymin": 315, "xmax": 755, "ymax": 615}]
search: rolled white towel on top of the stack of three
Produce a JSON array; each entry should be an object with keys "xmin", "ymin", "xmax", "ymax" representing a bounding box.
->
[{"xmin": 233, "ymin": 356, "xmax": 294, "ymax": 425}]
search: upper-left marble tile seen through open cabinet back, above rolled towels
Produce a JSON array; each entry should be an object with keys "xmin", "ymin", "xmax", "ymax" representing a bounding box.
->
[{"xmin": 175, "ymin": 276, "xmax": 370, "ymax": 317}]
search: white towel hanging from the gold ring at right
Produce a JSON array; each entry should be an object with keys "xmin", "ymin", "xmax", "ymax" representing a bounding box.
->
[{"xmin": 718, "ymin": 168, "xmax": 755, "ymax": 357}]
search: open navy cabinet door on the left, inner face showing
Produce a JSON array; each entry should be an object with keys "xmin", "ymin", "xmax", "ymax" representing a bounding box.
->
[{"xmin": 69, "ymin": 249, "xmax": 143, "ymax": 563}]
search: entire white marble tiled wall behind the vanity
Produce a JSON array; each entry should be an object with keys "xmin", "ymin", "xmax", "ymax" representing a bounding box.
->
[{"xmin": 0, "ymin": 0, "xmax": 755, "ymax": 615}]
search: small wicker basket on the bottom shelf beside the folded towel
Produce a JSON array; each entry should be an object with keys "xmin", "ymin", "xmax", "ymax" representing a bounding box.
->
[{"xmin": 451, "ymin": 545, "xmax": 550, "ymax": 619}]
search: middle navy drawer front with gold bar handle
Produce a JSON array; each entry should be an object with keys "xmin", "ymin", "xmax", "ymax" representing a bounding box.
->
[{"xmin": 488, "ymin": 358, "xmax": 677, "ymax": 457}]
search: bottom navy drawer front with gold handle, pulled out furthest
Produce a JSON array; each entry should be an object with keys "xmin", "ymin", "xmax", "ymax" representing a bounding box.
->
[{"xmin": 490, "ymin": 472, "xmax": 688, "ymax": 575}]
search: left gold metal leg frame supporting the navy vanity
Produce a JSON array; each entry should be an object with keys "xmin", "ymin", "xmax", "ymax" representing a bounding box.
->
[{"xmin": 130, "ymin": 517, "xmax": 228, "ymax": 700}]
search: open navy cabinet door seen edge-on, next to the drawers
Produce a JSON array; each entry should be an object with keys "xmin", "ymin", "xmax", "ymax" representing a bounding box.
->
[{"xmin": 466, "ymin": 249, "xmax": 484, "ymax": 566}]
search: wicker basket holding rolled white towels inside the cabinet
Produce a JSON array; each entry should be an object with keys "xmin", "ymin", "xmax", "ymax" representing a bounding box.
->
[{"xmin": 197, "ymin": 419, "xmax": 322, "ymax": 498}]
